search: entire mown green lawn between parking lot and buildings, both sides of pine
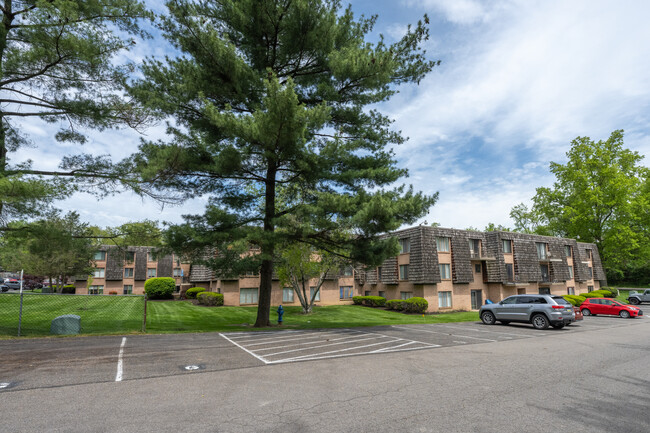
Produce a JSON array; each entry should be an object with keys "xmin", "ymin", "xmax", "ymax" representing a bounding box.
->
[{"xmin": 0, "ymin": 293, "xmax": 479, "ymax": 337}]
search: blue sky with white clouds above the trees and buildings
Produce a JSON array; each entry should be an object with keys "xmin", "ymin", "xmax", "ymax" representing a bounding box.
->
[{"xmin": 14, "ymin": 0, "xmax": 650, "ymax": 229}]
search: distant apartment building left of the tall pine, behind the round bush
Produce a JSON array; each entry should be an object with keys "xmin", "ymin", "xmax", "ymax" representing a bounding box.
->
[{"xmin": 75, "ymin": 245, "xmax": 190, "ymax": 295}]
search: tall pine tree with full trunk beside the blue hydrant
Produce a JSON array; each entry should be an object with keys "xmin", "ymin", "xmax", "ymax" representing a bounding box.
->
[{"xmin": 132, "ymin": 0, "xmax": 436, "ymax": 326}]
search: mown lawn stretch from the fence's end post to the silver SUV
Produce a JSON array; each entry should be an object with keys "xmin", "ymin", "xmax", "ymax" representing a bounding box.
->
[{"xmin": 147, "ymin": 301, "xmax": 479, "ymax": 333}]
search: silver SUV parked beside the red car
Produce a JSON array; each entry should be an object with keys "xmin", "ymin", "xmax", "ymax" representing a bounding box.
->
[{"xmin": 479, "ymin": 295, "xmax": 576, "ymax": 329}]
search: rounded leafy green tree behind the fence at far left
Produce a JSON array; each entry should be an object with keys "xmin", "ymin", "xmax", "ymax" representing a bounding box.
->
[{"xmin": 0, "ymin": 211, "xmax": 97, "ymax": 293}]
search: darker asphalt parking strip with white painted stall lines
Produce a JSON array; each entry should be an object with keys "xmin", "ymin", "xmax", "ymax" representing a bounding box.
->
[{"xmin": 0, "ymin": 316, "xmax": 648, "ymax": 392}]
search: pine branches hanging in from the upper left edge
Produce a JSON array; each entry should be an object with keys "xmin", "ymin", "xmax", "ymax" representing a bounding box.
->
[{"xmin": 0, "ymin": 0, "xmax": 149, "ymax": 224}]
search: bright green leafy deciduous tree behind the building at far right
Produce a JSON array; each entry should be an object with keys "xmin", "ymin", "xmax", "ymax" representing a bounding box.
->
[{"xmin": 513, "ymin": 130, "xmax": 650, "ymax": 276}]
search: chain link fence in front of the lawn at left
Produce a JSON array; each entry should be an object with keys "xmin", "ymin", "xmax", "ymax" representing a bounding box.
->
[{"xmin": 0, "ymin": 292, "xmax": 146, "ymax": 337}]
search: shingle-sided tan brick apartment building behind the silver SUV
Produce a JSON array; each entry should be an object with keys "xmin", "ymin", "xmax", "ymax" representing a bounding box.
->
[{"xmin": 355, "ymin": 226, "xmax": 607, "ymax": 312}]
